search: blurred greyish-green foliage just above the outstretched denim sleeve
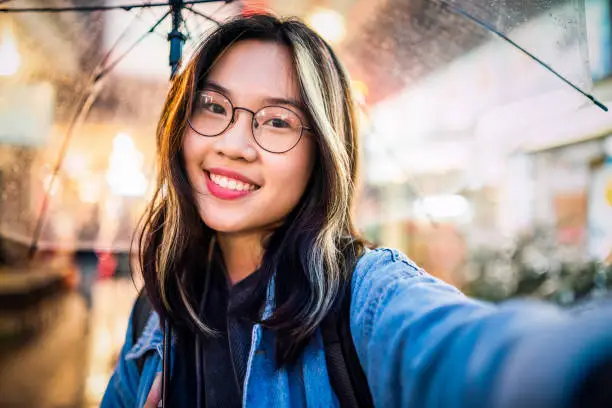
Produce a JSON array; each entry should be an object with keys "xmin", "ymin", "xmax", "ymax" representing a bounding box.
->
[{"xmin": 463, "ymin": 228, "xmax": 612, "ymax": 306}]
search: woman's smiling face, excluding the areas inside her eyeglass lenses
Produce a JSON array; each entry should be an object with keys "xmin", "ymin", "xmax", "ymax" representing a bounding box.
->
[{"xmin": 183, "ymin": 40, "xmax": 315, "ymax": 233}]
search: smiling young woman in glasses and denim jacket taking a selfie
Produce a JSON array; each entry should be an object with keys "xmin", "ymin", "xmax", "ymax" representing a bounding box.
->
[{"xmin": 102, "ymin": 15, "xmax": 612, "ymax": 408}]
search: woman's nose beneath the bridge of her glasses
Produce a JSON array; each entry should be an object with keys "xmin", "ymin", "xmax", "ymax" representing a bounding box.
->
[{"xmin": 215, "ymin": 109, "xmax": 257, "ymax": 162}]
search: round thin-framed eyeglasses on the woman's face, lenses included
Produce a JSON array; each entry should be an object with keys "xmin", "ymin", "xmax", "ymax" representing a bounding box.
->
[{"xmin": 187, "ymin": 91, "xmax": 310, "ymax": 153}]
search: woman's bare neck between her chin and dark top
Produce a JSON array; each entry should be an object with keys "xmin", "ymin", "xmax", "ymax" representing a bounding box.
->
[{"xmin": 217, "ymin": 232, "xmax": 263, "ymax": 285}]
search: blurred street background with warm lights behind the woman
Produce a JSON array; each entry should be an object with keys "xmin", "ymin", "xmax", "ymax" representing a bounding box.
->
[{"xmin": 0, "ymin": 0, "xmax": 612, "ymax": 408}]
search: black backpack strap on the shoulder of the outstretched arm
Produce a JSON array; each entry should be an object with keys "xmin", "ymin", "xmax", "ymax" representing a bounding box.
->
[{"xmin": 321, "ymin": 287, "xmax": 374, "ymax": 408}]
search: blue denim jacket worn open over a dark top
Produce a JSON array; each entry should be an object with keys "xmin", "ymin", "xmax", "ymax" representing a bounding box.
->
[{"xmin": 101, "ymin": 248, "xmax": 612, "ymax": 408}]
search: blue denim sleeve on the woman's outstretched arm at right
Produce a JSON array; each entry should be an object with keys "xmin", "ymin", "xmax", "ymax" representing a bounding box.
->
[{"xmin": 351, "ymin": 248, "xmax": 612, "ymax": 408}]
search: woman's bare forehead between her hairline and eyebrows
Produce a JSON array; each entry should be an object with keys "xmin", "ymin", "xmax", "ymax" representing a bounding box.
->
[{"xmin": 208, "ymin": 40, "xmax": 300, "ymax": 100}]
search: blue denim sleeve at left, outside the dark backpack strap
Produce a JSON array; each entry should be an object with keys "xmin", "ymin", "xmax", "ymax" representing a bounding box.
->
[{"xmin": 100, "ymin": 302, "xmax": 140, "ymax": 408}]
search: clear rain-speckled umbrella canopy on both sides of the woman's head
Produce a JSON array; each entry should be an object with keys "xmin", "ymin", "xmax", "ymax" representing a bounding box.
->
[{"xmin": 0, "ymin": 0, "xmax": 604, "ymax": 260}]
